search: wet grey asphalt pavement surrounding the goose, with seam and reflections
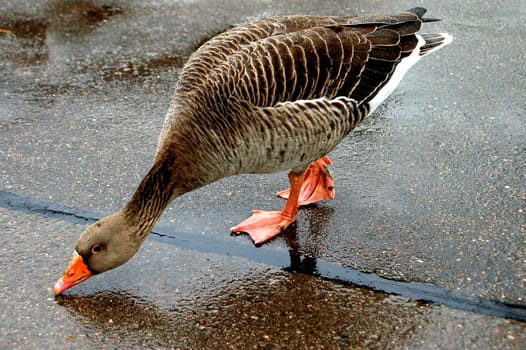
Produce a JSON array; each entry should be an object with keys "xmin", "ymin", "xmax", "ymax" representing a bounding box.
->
[{"xmin": 0, "ymin": 0, "xmax": 526, "ymax": 349}]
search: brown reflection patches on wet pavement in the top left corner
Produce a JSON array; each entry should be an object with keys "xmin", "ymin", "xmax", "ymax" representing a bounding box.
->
[{"xmin": 0, "ymin": 0, "xmax": 186, "ymax": 81}]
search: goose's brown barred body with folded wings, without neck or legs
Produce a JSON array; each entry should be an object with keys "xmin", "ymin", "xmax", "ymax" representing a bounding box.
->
[{"xmin": 158, "ymin": 9, "xmax": 450, "ymax": 183}]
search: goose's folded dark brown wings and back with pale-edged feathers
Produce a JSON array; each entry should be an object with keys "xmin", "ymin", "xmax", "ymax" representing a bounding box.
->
[{"xmin": 178, "ymin": 12, "xmax": 421, "ymax": 107}]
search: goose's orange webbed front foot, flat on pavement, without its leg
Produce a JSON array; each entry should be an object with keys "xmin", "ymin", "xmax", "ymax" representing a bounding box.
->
[{"xmin": 230, "ymin": 210, "xmax": 294, "ymax": 245}]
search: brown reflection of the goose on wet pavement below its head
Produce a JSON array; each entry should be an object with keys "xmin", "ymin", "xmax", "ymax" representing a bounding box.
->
[{"xmin": 59, "ymin": 272, "xmax": 428, "ymax": 348}]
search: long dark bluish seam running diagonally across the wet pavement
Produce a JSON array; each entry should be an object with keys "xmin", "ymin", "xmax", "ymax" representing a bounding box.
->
[{"xmin": 0, "ymin": 190, "xmax": 526, "ymax": 322}]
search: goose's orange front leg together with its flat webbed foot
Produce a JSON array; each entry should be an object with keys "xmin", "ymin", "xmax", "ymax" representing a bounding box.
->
[{"xmin": 230, "ymin": 171, "xmax": 304, "ymax": 245}]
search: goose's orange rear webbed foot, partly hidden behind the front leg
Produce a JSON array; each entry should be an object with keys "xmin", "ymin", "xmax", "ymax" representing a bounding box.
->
[{"xmin": 277, "ymin": 157, "xmax": 335, "ymax": 206}]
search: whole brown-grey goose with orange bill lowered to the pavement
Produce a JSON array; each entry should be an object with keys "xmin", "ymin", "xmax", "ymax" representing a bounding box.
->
[{"xmin": 54, "ymin": 7, "xmax": 452, "ymax": 295}]
